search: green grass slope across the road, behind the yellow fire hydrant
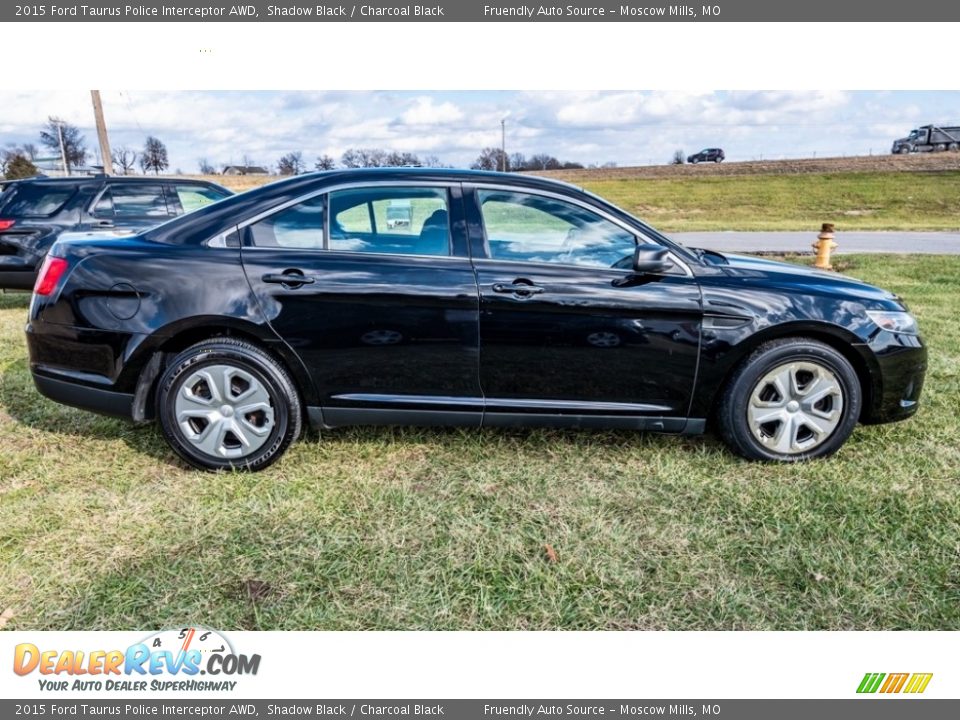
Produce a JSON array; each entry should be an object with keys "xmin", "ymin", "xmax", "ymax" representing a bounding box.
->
[{"xmin": 583, "ymin": 171, "xmax": 960, "ymax": 232}]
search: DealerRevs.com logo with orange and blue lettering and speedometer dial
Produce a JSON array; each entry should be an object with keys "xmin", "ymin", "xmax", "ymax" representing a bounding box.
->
[{"xmin": 13, "ymin": 628, "xmax": 260, "ymax": 692}]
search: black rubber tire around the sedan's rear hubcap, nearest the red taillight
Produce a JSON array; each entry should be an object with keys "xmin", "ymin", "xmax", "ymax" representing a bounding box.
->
[{"xmin": 156, "ymin": 338, "xmax": 303, "ymax": 471}]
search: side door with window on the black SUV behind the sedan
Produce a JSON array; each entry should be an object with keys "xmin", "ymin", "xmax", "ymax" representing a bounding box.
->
[{"xmin": 80, "ymin": 182, "xmax": 176, "ymax": 232}]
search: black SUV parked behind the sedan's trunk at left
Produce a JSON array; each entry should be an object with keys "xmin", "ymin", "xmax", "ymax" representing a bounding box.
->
[{"xmin": 0, "ymin": 175, "xmax": 233, "ymax": 290}]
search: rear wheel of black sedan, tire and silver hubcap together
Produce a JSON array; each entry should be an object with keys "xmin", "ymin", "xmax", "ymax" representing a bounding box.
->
[{"xmin": 157, "ymin": 338, "xmax": 302, "ymax": 470}]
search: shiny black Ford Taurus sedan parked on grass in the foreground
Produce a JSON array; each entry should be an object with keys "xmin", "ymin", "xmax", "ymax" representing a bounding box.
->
[{"xmin": 27, "ymin": 169, "xmax": 926, "ymax": 470}]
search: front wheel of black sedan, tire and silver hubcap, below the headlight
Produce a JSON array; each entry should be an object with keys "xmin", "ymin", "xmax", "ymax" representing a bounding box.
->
[{"xmin": 717, "ymin": 338, "xmax": 861, "ymax": 462}]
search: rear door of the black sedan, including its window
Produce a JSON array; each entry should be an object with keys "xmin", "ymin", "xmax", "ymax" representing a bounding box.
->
[{"xmin": 241, "ymin": 182, "xmax": 483, "ymax": 425}]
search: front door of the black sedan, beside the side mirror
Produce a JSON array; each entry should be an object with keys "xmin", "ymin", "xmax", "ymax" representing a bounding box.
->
[{"xmin": 465, "ymin": 186, "xmax": 701, "ymax": 430}]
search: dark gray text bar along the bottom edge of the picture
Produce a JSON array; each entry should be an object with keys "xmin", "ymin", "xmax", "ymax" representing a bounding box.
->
[{"xmin": 0, "ymin": 693, "xmax": 960, "ymax": 720}]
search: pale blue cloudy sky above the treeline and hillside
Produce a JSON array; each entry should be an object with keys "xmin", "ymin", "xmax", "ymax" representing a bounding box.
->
[{"xmin": 0, "ymin": 90, "xmax": 960, "ymax": 173}]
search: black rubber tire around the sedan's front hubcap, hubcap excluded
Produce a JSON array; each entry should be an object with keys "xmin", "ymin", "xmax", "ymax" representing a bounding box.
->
[{"xmin": 716, "ymin": 338, "xmax": 862, "ymax": 462}]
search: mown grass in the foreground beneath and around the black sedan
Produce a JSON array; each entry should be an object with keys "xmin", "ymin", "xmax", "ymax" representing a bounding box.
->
[{"xmin": 0, "ymin": 256, "xmax": 960, "ymax": 630}]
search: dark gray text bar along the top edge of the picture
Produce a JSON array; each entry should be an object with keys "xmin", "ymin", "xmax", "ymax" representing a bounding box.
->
[{"xmin": 7, "ymin": 0, "xmax": 960, "ymax": 22}]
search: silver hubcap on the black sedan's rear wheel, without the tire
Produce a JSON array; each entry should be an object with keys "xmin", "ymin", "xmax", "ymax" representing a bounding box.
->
[{"xmin": 174, "ymin": 365, "xmax": 274, "ymax": 458}]
